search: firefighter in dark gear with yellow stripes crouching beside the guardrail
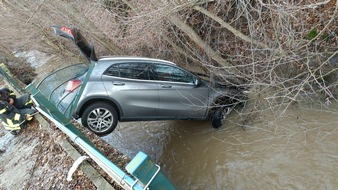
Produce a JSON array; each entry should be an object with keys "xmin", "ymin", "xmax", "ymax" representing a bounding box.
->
[{"xmin": 0, "ymin": 88, "xmax": 36, "ymax": 135}]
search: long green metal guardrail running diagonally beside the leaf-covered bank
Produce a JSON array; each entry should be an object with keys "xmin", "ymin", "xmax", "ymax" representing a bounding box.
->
[{"xmin": 0, "ymin": 64, "xmax": 175, "ymax": 190}]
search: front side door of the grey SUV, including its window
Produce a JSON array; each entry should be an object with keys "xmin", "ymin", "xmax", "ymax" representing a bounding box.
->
[{"xmin": 152, "ymin": 64, "xmax": 208, "ymax": 119}]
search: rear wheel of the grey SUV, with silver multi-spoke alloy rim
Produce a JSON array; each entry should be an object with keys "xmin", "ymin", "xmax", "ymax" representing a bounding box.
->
[{"xmin": 81, "ymin": 102, "xmax": 118, "ymax": 136}]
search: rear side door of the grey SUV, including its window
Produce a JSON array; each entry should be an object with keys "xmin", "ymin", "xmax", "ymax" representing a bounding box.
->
[{"xmin": 102, "ymin": 62, "xmax": 158, "ymax": 120}]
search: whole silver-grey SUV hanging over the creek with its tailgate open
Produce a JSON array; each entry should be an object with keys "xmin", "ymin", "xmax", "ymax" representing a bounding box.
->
[{"xmin": 42, "ymin": 26, "xmax": 246, "ymax": 136}]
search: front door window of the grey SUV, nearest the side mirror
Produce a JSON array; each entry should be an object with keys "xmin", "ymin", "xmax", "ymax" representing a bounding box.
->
[{"xmin": 153, "ymin": 64, "xmax": 194, "ymax": 83}]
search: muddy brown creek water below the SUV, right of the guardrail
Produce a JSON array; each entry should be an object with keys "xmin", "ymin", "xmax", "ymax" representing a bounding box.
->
[{"xmin": 104, "ymin": 101, "xmax": 338, "ymax": 189}]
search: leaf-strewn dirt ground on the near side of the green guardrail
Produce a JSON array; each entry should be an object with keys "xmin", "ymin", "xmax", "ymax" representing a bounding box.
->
[{"xmin": 0, "ymin": 120, "xmax": 96, "ymax": 190}]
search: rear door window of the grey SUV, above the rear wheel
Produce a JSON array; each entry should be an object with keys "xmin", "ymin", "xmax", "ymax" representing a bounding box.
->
[{"xmin": 104, "ymin": 63, "xmax": 150, "ymax": 80}]
